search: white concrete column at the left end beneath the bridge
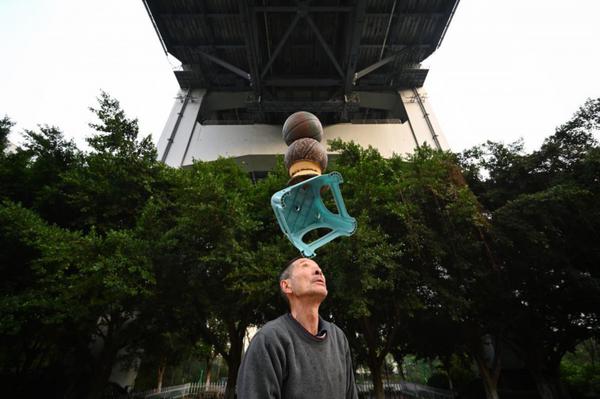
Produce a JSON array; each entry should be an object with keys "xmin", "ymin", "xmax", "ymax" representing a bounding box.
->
[{"xmin": 157, "ymin": 89, "xmax": 206, "ymax": 167}]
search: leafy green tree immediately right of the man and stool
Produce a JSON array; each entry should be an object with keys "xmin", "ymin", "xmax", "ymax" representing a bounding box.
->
[{"xmin": 322, "ymin": 142, "xmax": 489, "ymax": 398}]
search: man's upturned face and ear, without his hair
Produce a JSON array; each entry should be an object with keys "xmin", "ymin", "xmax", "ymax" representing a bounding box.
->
[{"xmin": 282, "ymin": 258, "xmax": 327, "ymax": 299}]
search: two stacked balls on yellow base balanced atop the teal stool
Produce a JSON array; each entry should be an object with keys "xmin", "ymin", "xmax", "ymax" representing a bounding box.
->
[{"xmin": 283, "ymin": 111, "xmax": 327, "ymax": 186}]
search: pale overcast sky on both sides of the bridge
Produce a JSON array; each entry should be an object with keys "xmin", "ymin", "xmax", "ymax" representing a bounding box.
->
[{"xmin": 0, "ymin": 0, "xmax": 600, "ymax": 151}]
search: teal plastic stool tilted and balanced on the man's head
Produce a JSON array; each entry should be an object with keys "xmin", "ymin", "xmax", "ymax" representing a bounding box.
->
[{"xmin": 271, "ymin": 172, "xmax": 356, "ymax": 258}]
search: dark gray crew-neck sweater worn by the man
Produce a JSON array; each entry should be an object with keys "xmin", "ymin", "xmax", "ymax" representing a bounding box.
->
[{"xmin": 237, "ymin": 314, "xmax": 358, "ymax": 399}]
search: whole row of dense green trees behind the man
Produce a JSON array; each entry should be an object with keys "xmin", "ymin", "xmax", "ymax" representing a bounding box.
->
[{"xmin": 0, "ymin": 93, "xmax": 600, "ymax": 399}]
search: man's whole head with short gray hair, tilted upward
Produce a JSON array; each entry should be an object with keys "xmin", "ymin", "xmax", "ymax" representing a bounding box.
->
[{"xmin": 279, "ymin": 258, "xmax": 327, "ymax": 305}]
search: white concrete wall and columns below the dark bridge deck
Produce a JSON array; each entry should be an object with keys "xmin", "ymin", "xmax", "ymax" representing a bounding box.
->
[{"xmin": 158, "ymin": 88, "xmax": 448, "ymax": 170}]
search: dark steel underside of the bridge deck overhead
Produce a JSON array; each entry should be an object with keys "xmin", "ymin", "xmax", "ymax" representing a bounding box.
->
[{"xmin": 145, "ymin": 0, "xmax": 458, "ymax": 125}]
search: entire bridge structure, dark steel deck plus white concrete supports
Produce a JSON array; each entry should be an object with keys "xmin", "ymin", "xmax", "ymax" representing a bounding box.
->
[{"xmin": 144, "ymin": 0, "xmax": 458, "ymax": 172}]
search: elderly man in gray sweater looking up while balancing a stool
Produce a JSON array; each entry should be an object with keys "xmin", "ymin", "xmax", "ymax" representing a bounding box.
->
[{"xmin": 237, "ymin": 258, "xmax": 358, "ymax": 399}]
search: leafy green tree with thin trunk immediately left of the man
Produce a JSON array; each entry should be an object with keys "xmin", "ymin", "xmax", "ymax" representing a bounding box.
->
[{"xmin": 140, "ymin": 159, "xmax": 283, "ymax": 398}]
